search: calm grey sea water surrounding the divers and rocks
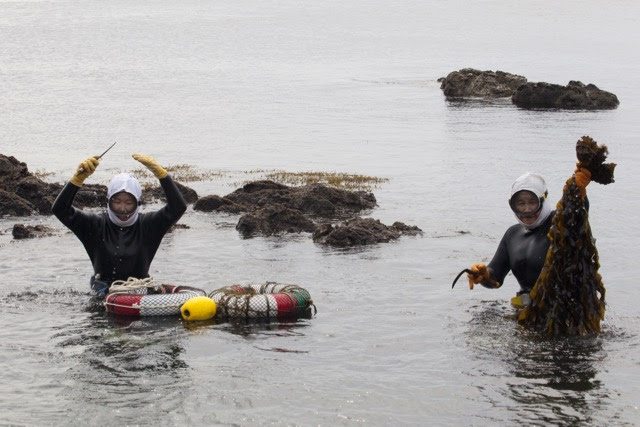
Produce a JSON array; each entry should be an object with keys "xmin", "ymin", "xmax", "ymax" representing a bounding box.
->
[{"xmin": 0, "ymin": 0, "xmax": 640, "ymax": 425}]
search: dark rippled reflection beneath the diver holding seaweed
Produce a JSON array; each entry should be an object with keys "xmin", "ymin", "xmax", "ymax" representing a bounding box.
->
[{"xmin": 467, "ymin": 302, "xmax": 611, "ymax": 424}]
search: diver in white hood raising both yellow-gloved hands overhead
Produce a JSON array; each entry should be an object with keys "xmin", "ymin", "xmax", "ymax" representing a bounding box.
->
[{"xmin": 52, "ymin": 154, "xmax": 187, "ymax": 297}]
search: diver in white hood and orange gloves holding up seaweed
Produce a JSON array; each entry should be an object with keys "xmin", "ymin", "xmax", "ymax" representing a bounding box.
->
[{"xmin": 467, "ymin": 170, "xmax": 590, "ymax": 308}]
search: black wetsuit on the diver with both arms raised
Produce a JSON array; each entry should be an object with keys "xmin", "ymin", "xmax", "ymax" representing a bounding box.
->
[{"xmin": 52, "ymin": 176, "xmax": 187, "ymax": 290}]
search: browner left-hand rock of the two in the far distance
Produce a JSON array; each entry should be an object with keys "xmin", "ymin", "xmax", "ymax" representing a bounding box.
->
[{"xmin": 438, "ymin": 68, "xmax": 527, "ymax": 98}]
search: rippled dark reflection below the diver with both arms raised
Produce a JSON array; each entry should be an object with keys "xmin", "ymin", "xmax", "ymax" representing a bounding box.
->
[{"xmin": 55, "ymin": 312, "xmax": 193, "ymax": 419}]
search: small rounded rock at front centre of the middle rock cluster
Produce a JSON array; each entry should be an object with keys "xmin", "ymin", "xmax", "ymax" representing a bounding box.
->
[{"xmin": 236, "ymin": 204, "xmax": 315, "ymax": 237}]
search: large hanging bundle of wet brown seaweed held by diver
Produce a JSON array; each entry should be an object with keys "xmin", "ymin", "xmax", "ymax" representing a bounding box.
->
[{"xmin": 518, "ymin": 136, "xmax": 616, "ymax": 336}]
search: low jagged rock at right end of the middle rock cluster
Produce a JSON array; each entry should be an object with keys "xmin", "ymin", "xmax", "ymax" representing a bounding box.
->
[{"xmin": 313, "ymin": 218, "xmax": 422, "ymax": 247}]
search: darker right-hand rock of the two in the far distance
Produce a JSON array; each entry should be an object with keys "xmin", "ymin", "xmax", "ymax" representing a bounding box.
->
[{"xmin": 511, "ymin": 81, "xmax": 620, "ymax": 110}]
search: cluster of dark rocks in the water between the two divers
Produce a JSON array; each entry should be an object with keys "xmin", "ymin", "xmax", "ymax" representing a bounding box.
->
[{"xmin": 198, "ymin": 180, "xmax": 421, "ymax": 247}]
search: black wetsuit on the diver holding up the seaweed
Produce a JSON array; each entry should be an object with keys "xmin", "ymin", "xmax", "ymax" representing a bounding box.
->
[{"xmin": 486, "ymin": 212, "xmax": 555, "ymax": 293}]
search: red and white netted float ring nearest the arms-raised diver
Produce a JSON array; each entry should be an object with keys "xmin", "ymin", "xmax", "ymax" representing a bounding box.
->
[{"xmin": 104, "ymin": 278, "xmax": 206, "ymax": 316}]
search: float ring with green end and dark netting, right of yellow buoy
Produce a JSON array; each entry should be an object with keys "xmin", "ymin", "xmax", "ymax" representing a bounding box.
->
[{"xmin": 209, "ymin": 282, "xmax": 317, "ymax": 321}]
